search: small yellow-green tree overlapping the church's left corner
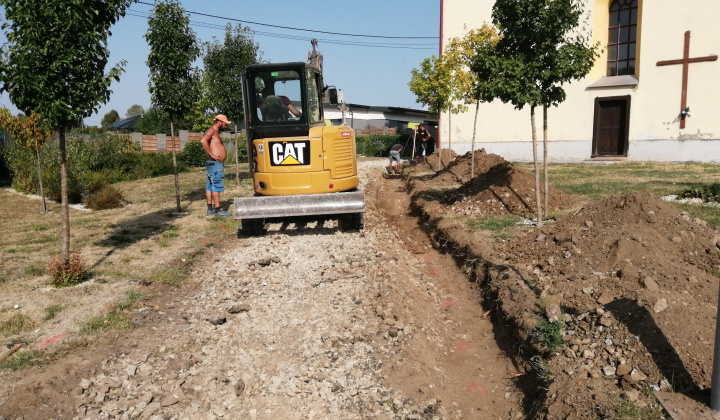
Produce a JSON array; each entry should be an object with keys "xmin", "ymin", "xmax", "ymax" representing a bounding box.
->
[{"xmin": 408, "ymin": 55, "xmax": 467, "ymax": 168}]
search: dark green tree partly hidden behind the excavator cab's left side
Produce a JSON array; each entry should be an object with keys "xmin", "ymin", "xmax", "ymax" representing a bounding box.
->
[{"xmin": 203, "ymin": 24, "xmax": 260, "ymax": 185}]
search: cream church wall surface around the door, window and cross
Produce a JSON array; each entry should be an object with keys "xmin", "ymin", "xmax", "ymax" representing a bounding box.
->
[{"xmin": 440, "ymin": 0, "xmax": 720, "ymax": 161}]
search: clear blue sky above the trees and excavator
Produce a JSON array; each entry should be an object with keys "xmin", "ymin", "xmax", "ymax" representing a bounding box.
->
[{"xmin": 0, "ymin": 0, "xmax": 440, "ymax": 125}]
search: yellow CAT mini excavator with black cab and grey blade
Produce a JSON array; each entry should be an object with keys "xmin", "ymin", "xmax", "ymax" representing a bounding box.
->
[{"xmin": 234, "ymin": 40, "xmax": 365, "ymax": 235}]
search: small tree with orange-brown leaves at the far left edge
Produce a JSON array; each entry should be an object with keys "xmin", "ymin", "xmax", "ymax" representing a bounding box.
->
[{"xmin": 0, "ymin": 108, "xmax": 53, "ymax": 213}]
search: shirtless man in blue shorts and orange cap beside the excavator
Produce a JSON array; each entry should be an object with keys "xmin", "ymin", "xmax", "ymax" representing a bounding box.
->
[{"xmin": 200, "ymin": 114, "xmax": 230, "ymax": 216}]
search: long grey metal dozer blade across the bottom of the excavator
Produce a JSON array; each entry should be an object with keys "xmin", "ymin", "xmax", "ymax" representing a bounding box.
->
[{"xmin": 234, "ymin": 191, "xmax": 365, "ymax": 219}]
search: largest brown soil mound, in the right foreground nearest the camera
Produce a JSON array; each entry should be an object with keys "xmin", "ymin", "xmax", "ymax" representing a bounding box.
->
[{"xmin": 496, "ymin": 191, "xmax": 720, "ymax": 418}]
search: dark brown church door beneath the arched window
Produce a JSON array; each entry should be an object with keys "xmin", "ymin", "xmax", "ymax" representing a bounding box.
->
[{"xmin": 592, "ymin": 95, "xmax": 630, "ymax": 157}]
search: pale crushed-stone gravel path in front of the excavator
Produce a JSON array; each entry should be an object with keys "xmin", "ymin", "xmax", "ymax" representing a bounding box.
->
[{"xmin": 74, "ymin": 160, "xmax": 520, "ymax": 419}]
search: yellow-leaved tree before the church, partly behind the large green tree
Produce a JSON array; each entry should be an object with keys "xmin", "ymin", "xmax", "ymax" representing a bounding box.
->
[{"xmin": 445, "ymin": 23, "xmax": 500, "ymax": 177}]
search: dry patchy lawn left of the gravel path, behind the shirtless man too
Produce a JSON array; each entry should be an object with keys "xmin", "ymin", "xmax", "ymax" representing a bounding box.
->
[{"xmin": 0, "ymin": 165, "xmax": 252, "ymax": 370}]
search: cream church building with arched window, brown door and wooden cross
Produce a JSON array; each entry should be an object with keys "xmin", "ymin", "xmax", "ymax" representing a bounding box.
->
[{"xmin": 439, "ymin": 0, "xmax": 720, "ymax": 162}]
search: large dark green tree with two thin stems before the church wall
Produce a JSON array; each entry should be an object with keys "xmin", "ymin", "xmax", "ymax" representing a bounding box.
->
[{"xmin": 492, "ymin": 0, "xmax": 597, "ymax": 224}]
